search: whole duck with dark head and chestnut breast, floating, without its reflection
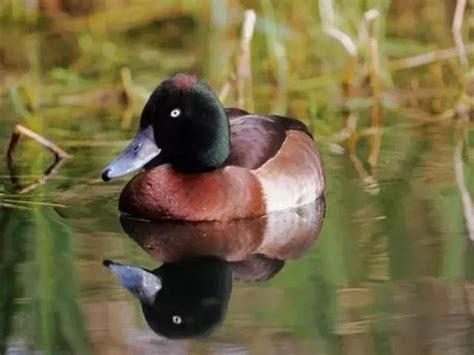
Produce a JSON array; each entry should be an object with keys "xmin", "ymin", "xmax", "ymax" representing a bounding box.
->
[{"xmin": 102, "ymin": 73, "xmax": 326, "ymax": 222}]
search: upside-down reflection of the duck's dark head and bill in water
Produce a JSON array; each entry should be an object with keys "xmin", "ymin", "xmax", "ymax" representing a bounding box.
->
[{"xmin": 104, "ymin": 258, "xmax": 232, "ymax": 338}]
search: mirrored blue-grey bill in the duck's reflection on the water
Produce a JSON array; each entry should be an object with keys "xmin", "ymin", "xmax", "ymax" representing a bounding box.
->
[{"xmin": 103, "ymin": 260, "xmax": 161, "ymax": 305}]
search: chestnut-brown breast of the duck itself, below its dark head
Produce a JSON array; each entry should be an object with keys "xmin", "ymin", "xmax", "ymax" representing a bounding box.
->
[{"xmin": 119, "ymin": 164, "xmax": 265, "ymax": 221}]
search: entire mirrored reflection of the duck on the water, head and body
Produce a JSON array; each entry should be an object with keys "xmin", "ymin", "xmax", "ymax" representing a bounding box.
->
[{"xmin": 104, "ymin": 199, "xmax": 325, "ymax": 338}]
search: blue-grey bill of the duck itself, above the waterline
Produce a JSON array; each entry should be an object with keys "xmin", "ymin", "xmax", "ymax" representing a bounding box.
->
[{"xmin": 102, "ymin": 125, "xmax": 161, "ymax": 181}]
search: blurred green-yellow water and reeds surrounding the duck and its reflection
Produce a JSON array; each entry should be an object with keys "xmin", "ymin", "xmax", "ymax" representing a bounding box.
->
[{"xmin": 0, "ymin": 0, "xmax": 474, "ymax": 354}]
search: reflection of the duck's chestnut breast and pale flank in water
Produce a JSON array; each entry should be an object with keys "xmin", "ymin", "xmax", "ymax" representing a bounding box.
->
[{"xmin": 120, "ymin": 199, "xmax": 325, "ymax": 262}]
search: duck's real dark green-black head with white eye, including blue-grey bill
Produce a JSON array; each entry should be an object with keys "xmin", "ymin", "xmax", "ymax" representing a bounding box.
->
[{"xmin": 102, "ymin": 74, "xmax": 230, "ymax": 181}]
